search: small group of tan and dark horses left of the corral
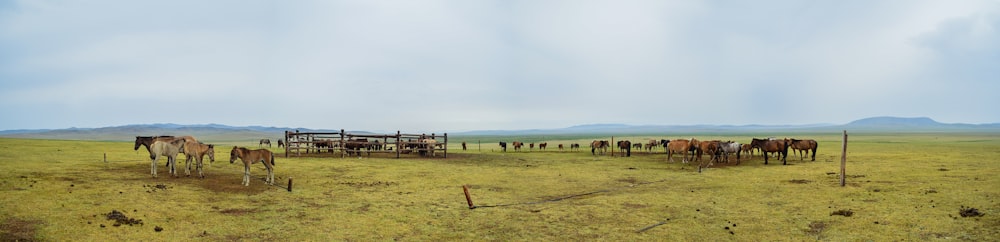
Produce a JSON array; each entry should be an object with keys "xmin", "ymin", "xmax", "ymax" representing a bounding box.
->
[{"xmin": 133, "ymin": 136, "xmax": 274, "ymax": 186}]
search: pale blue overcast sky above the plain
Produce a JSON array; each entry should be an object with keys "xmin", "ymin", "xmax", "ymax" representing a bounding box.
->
[{"xmin": 0, "ymin": 0, "xmax": 1000, "ymax": 132}]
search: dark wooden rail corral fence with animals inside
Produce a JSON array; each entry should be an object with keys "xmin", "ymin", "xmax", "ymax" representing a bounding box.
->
[{"xmin": 284, "ymin": 129, "xmax": 448, "ymax": 158}]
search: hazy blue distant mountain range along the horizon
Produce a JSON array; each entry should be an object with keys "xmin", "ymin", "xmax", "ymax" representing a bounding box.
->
[{"xmin": 0, "ymin": 117, "xmax": 1000, "ymax": 141}]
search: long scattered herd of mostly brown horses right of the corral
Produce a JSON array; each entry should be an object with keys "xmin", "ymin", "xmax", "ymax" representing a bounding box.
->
[{"xmin": 496, "ymin": 137, "xmax": 819, "ymax": 165}]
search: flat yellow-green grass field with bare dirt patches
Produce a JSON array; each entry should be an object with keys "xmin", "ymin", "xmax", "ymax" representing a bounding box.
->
[{"xmin": 0, "ymin": 133, "xmax": 1000, "ymax": 241}]
